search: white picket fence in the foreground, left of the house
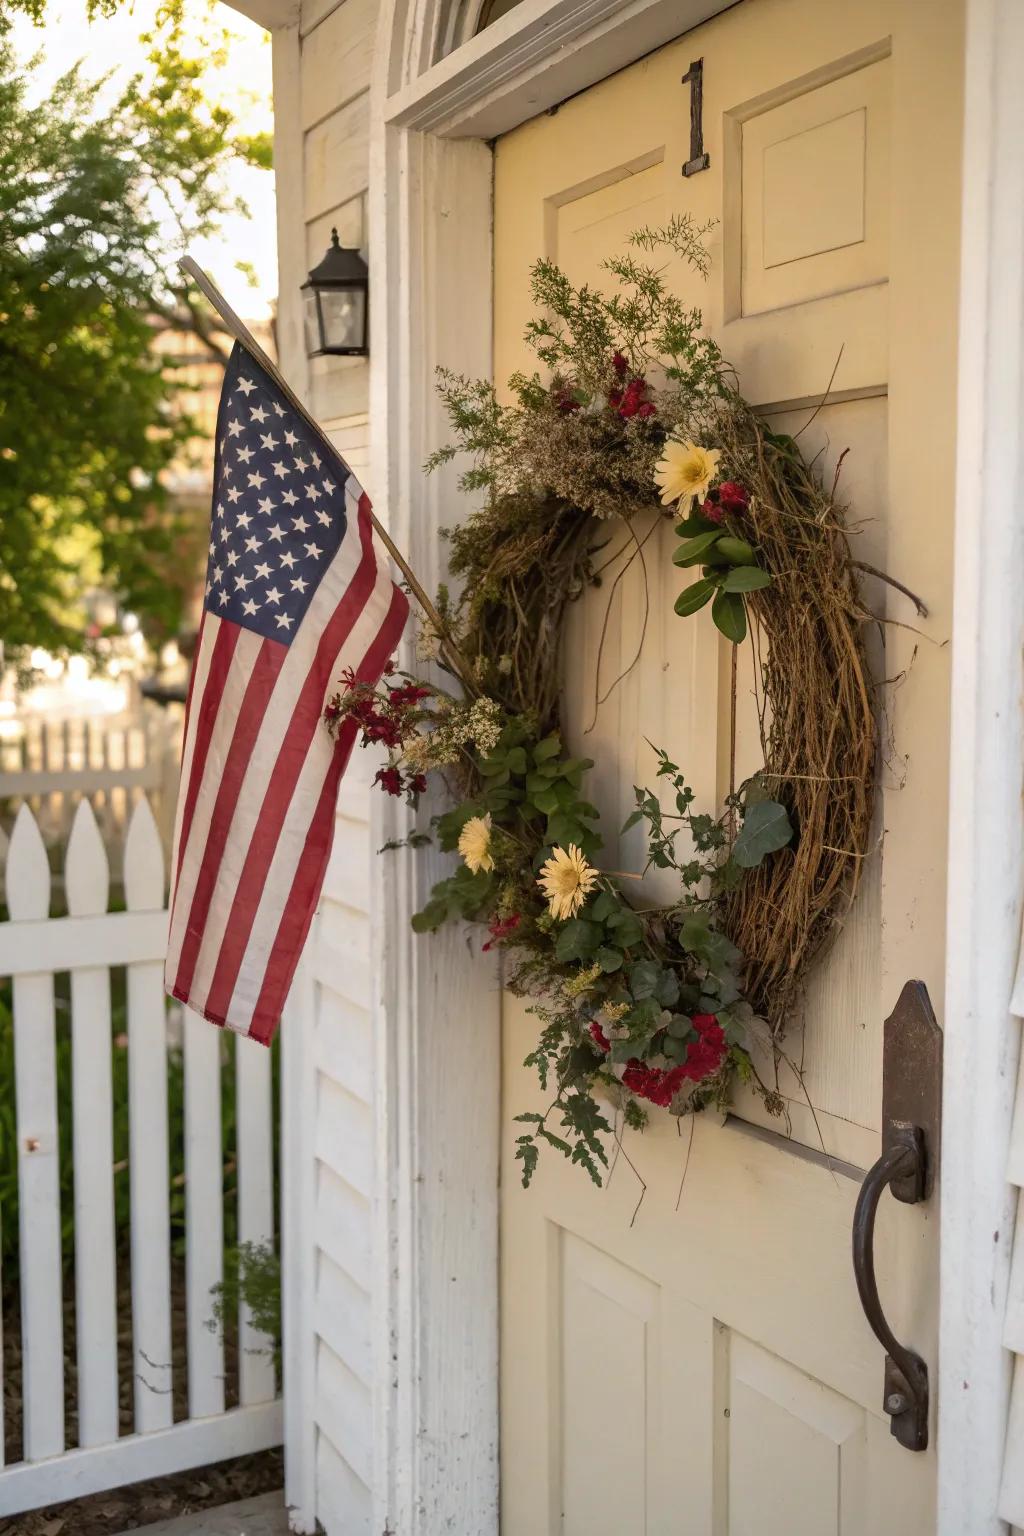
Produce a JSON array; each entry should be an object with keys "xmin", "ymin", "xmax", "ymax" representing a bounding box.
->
[{"xmin": 0, "ymin": 799, "xmax": 281, "ymax": 1516}]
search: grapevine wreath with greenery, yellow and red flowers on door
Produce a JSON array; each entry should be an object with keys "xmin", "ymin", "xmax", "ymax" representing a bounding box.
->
[{"xmin": 325, "ymin": 217, "xmax": 906, "ymax": 1183}]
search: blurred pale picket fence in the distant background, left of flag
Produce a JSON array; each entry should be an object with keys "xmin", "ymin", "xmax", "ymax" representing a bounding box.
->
[{"xmin": 0, "ymin": 705, "xmax": 181, "ymax": 874}]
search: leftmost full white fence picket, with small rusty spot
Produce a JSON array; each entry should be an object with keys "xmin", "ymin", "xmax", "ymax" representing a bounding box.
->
[{"xmin": 6, "ymin": 805, "xmax": 64, "ymax": 1461}]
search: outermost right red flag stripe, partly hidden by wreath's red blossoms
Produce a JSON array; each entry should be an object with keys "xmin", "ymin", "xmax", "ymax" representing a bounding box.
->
[{"xmin": 249, "ymin": 587, "xmax": 408, "ymax": 1046}]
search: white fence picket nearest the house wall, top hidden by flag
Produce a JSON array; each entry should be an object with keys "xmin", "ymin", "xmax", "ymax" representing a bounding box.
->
[{"xmin": 235, "ymin": 1035, "xmax": 275, "ymax": 1405}]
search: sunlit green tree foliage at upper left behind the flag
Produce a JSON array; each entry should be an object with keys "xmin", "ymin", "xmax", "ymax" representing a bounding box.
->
[{"xmin": 0, "ymin": 9, "xmax": 270, "ymax": 663}]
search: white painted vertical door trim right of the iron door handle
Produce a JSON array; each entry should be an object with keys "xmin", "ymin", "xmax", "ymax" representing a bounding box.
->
[{"xmin": 938, "ymin": 0, "xmax": 1024, "ymax": 1536}]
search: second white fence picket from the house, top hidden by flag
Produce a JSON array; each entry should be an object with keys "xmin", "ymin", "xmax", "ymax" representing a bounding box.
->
[{"xmin": 184, "ymin": 1009, "xmax": 224, "ymax": 1419}]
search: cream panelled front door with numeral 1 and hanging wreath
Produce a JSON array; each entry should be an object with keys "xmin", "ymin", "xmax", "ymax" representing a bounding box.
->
[{"xmin": 494, "ymin": 0, "xmax": 961, "ymax": 1536}]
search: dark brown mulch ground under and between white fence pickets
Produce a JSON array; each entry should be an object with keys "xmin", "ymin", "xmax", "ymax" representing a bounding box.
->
[{"xmin": 0, "ymin": 1255, "xmax": 284, "ymax": 1536}]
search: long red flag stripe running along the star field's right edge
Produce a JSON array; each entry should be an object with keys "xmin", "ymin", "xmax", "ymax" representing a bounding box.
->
[{"xmin": 192, "ymin": 496, "xmax": 378, "ymax": 1023}]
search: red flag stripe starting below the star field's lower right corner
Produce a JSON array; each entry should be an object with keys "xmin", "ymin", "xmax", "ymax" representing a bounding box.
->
[{"xmin": 173, "ymin": 625, "xmax": 289, "ymax": 998}]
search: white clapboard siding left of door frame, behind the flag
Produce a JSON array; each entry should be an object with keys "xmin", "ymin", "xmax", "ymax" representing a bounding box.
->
[{"xmin": 275, "ymin": 9, "xmax": 379, "ymax": 1536}]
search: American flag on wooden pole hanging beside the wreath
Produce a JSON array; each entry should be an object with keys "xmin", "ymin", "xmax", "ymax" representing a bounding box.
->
[{"xmin": 166, "ymin": 344, "xmax": 408, "ymax": 1043}]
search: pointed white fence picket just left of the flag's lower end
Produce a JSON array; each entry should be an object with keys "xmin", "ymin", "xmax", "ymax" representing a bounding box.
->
[{"xmin": 124, "ymin": 800, "xmax": 173, "ymax": 1433}]
